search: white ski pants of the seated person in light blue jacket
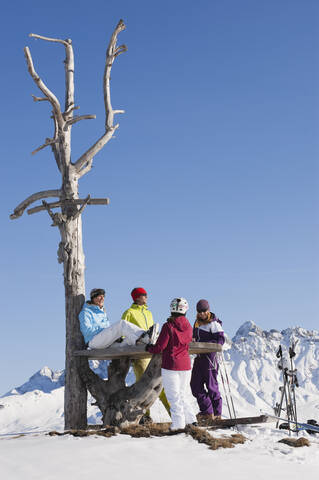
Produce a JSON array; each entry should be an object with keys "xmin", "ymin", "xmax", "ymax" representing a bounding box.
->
[{"xmin": 89, "ymin": 320, "xmax": 145, "ymax": 348}]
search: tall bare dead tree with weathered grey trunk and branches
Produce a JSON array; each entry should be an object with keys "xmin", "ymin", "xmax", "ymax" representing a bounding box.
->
[{"xmin": 10, "ymin": 20, "xmax": 165, "ymax": 428}]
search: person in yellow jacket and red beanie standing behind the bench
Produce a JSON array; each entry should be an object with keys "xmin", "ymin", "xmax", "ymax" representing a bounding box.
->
[{"xmin": 122, "ymin": 287, "xmax": 170, "ymax": 423}]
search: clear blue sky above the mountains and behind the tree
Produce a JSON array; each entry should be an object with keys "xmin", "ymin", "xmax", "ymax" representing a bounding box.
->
[{"xmin": 0, "ymin": 0, "xmax": 319, "ymax": 393}]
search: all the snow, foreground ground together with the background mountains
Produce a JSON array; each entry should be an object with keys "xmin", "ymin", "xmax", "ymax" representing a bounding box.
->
[{"xmin": 0, "ymin": 322, "xmax": 319, "ymax": 480}]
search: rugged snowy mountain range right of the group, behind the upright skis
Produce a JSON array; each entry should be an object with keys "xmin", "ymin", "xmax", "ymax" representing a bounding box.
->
[{"xmin": 224, "ymin": 322, "xmax": 319, "ymax": 418}]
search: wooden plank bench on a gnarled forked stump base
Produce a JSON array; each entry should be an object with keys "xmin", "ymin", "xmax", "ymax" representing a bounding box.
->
[{"xmin": 74, "ymin": 342, "xmax": 222, "ymax": 426}]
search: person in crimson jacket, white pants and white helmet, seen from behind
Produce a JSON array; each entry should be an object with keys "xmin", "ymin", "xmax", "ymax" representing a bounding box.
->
[{"xmin": 146, "ymin": 298, "xmax": 196, "ymax": 430}]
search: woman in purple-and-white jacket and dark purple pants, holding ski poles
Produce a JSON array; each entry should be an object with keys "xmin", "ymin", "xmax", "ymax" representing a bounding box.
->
[{"xmin": 191, "ymin": 299, "xmax": 225, "ymax": 421}]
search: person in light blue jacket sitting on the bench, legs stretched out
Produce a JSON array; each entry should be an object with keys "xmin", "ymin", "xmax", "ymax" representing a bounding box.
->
[{"xmin": 79, "ymin": 288, "xmax": 158, "ymax": 348}]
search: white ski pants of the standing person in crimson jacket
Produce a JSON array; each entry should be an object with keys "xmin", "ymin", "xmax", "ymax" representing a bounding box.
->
[{"xmin": 162, "ymin": 368, "xmax": 196, "ymax": 430}]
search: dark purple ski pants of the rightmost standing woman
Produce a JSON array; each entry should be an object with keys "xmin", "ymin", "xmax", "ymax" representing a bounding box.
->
[{"xmin": 191, "ymin": 355, "xmax": 222, "ymax": 415}]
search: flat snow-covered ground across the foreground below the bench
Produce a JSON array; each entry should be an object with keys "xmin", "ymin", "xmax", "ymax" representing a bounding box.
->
[{"xmin": 0, "ymin": 427, "xmax": 319, "ymax": 480}]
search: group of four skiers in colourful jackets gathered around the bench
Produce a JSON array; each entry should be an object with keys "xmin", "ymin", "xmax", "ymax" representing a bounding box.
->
[{"xmin": 79, "ymin": 287, "xmax": 224, "ymax": 430}]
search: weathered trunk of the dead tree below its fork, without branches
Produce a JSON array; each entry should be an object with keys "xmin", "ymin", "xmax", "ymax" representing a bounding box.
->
[{"xmin": 58, "ymin": 168, "xmax": 87, "ymax": 428}]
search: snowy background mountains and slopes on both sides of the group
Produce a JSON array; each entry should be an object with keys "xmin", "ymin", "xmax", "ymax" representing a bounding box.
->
[{"xmin": 0, "ymin": 322, "xmax": 319, "ymax": 433}]
